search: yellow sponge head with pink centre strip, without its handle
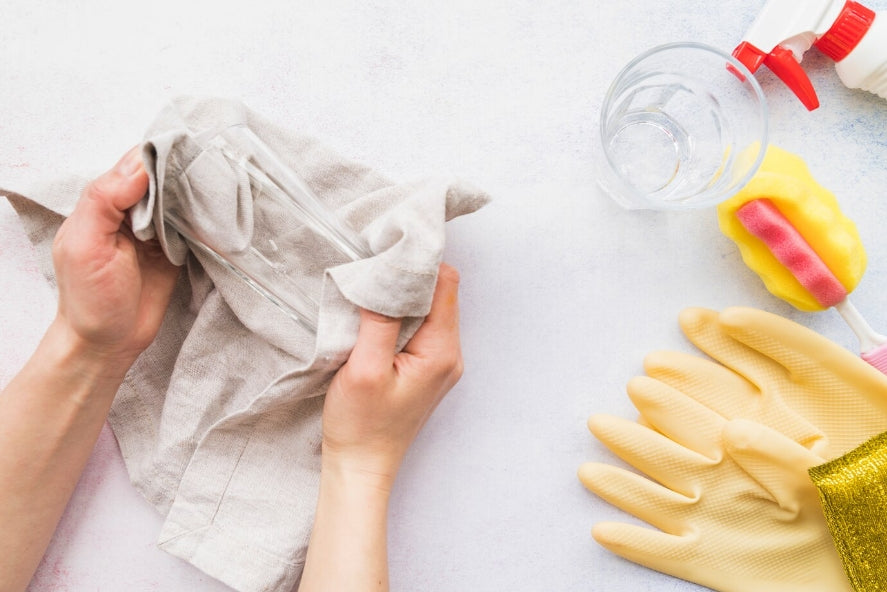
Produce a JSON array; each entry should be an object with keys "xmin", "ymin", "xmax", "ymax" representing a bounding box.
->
[{"xmin": 718, "ymin": 146, "xmax": 866, "ymax": 311}]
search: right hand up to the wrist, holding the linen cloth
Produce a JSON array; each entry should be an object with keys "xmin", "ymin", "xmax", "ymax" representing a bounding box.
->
[{"xmin": 323, "ymin": 264, "xmax": 462, "ymax": 485}]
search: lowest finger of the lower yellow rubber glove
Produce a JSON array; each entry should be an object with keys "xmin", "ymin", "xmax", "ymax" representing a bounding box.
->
[{"xmin": 591, "ymin": 522, "xmax": 692, "ymax": 579}]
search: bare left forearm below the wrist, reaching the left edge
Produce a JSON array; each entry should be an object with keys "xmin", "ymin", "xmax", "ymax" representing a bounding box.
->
[{"xmin": 0, "ymin": 322, "xmax": 125, "ymax": 592}]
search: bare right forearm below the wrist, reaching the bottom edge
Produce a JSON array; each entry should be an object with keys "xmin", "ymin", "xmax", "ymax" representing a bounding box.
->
[{"xmin": 299, "ymin": 457, "xmax": 391, "ymax": 592}]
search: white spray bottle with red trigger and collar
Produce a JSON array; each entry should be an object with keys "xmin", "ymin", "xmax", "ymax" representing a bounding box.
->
[{"xmin": 733, "ymin": 0, "xmax": 887, "ymax": 111}]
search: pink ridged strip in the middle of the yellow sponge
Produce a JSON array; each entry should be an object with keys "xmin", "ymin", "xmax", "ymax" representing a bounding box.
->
[{"xmin": 736, "ymin": 199, "xmax": 847, "ymax": 308}]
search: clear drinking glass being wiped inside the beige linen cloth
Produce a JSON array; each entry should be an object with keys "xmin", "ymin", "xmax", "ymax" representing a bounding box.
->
[{"xmin": 164, "ymin": 125, "xmax": 372, "ymax": 333}]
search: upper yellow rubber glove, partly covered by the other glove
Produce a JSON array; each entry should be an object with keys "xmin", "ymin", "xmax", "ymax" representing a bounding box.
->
[{"xmin": 676, "ymin": 308, "xmax": 887, "ymax": 459}]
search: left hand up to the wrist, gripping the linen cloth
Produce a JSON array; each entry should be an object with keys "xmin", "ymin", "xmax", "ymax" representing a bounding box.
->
[{"xmin": 52, "ymin": 147, "xmax": 178, "ymax": 372}]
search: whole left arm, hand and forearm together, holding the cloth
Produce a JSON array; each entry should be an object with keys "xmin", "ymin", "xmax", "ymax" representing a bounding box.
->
[{"xmin": 0, "ymin": 150, "xmax": 176, "ymax": 592}]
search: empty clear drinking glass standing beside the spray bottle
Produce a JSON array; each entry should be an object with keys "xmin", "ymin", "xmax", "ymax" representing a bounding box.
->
[{"xmin": 598, "ymin": 43, "xmax": 768, "ymax": 210}]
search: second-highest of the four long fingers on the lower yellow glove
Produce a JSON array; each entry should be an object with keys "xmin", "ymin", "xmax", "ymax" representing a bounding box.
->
[{"xmin": 588, "ymin": 415, "xmax": 717, "ymax": 497}]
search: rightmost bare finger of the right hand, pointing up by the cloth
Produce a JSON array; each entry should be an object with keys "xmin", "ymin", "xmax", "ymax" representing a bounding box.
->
[{"xmin": 404, "ymin": 263, "xmax": 459, "ymax": 355}]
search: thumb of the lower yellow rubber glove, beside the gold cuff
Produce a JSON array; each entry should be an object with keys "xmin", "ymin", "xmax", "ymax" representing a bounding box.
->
[{"xmin": 723, "ymin": 419, "xmax": 825, "ymax": 515}]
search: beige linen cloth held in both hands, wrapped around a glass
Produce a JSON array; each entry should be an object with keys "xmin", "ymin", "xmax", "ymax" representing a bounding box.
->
[{"xmin": 3, "ymin": 97, "xmax": 488, "ymax": 592}]
